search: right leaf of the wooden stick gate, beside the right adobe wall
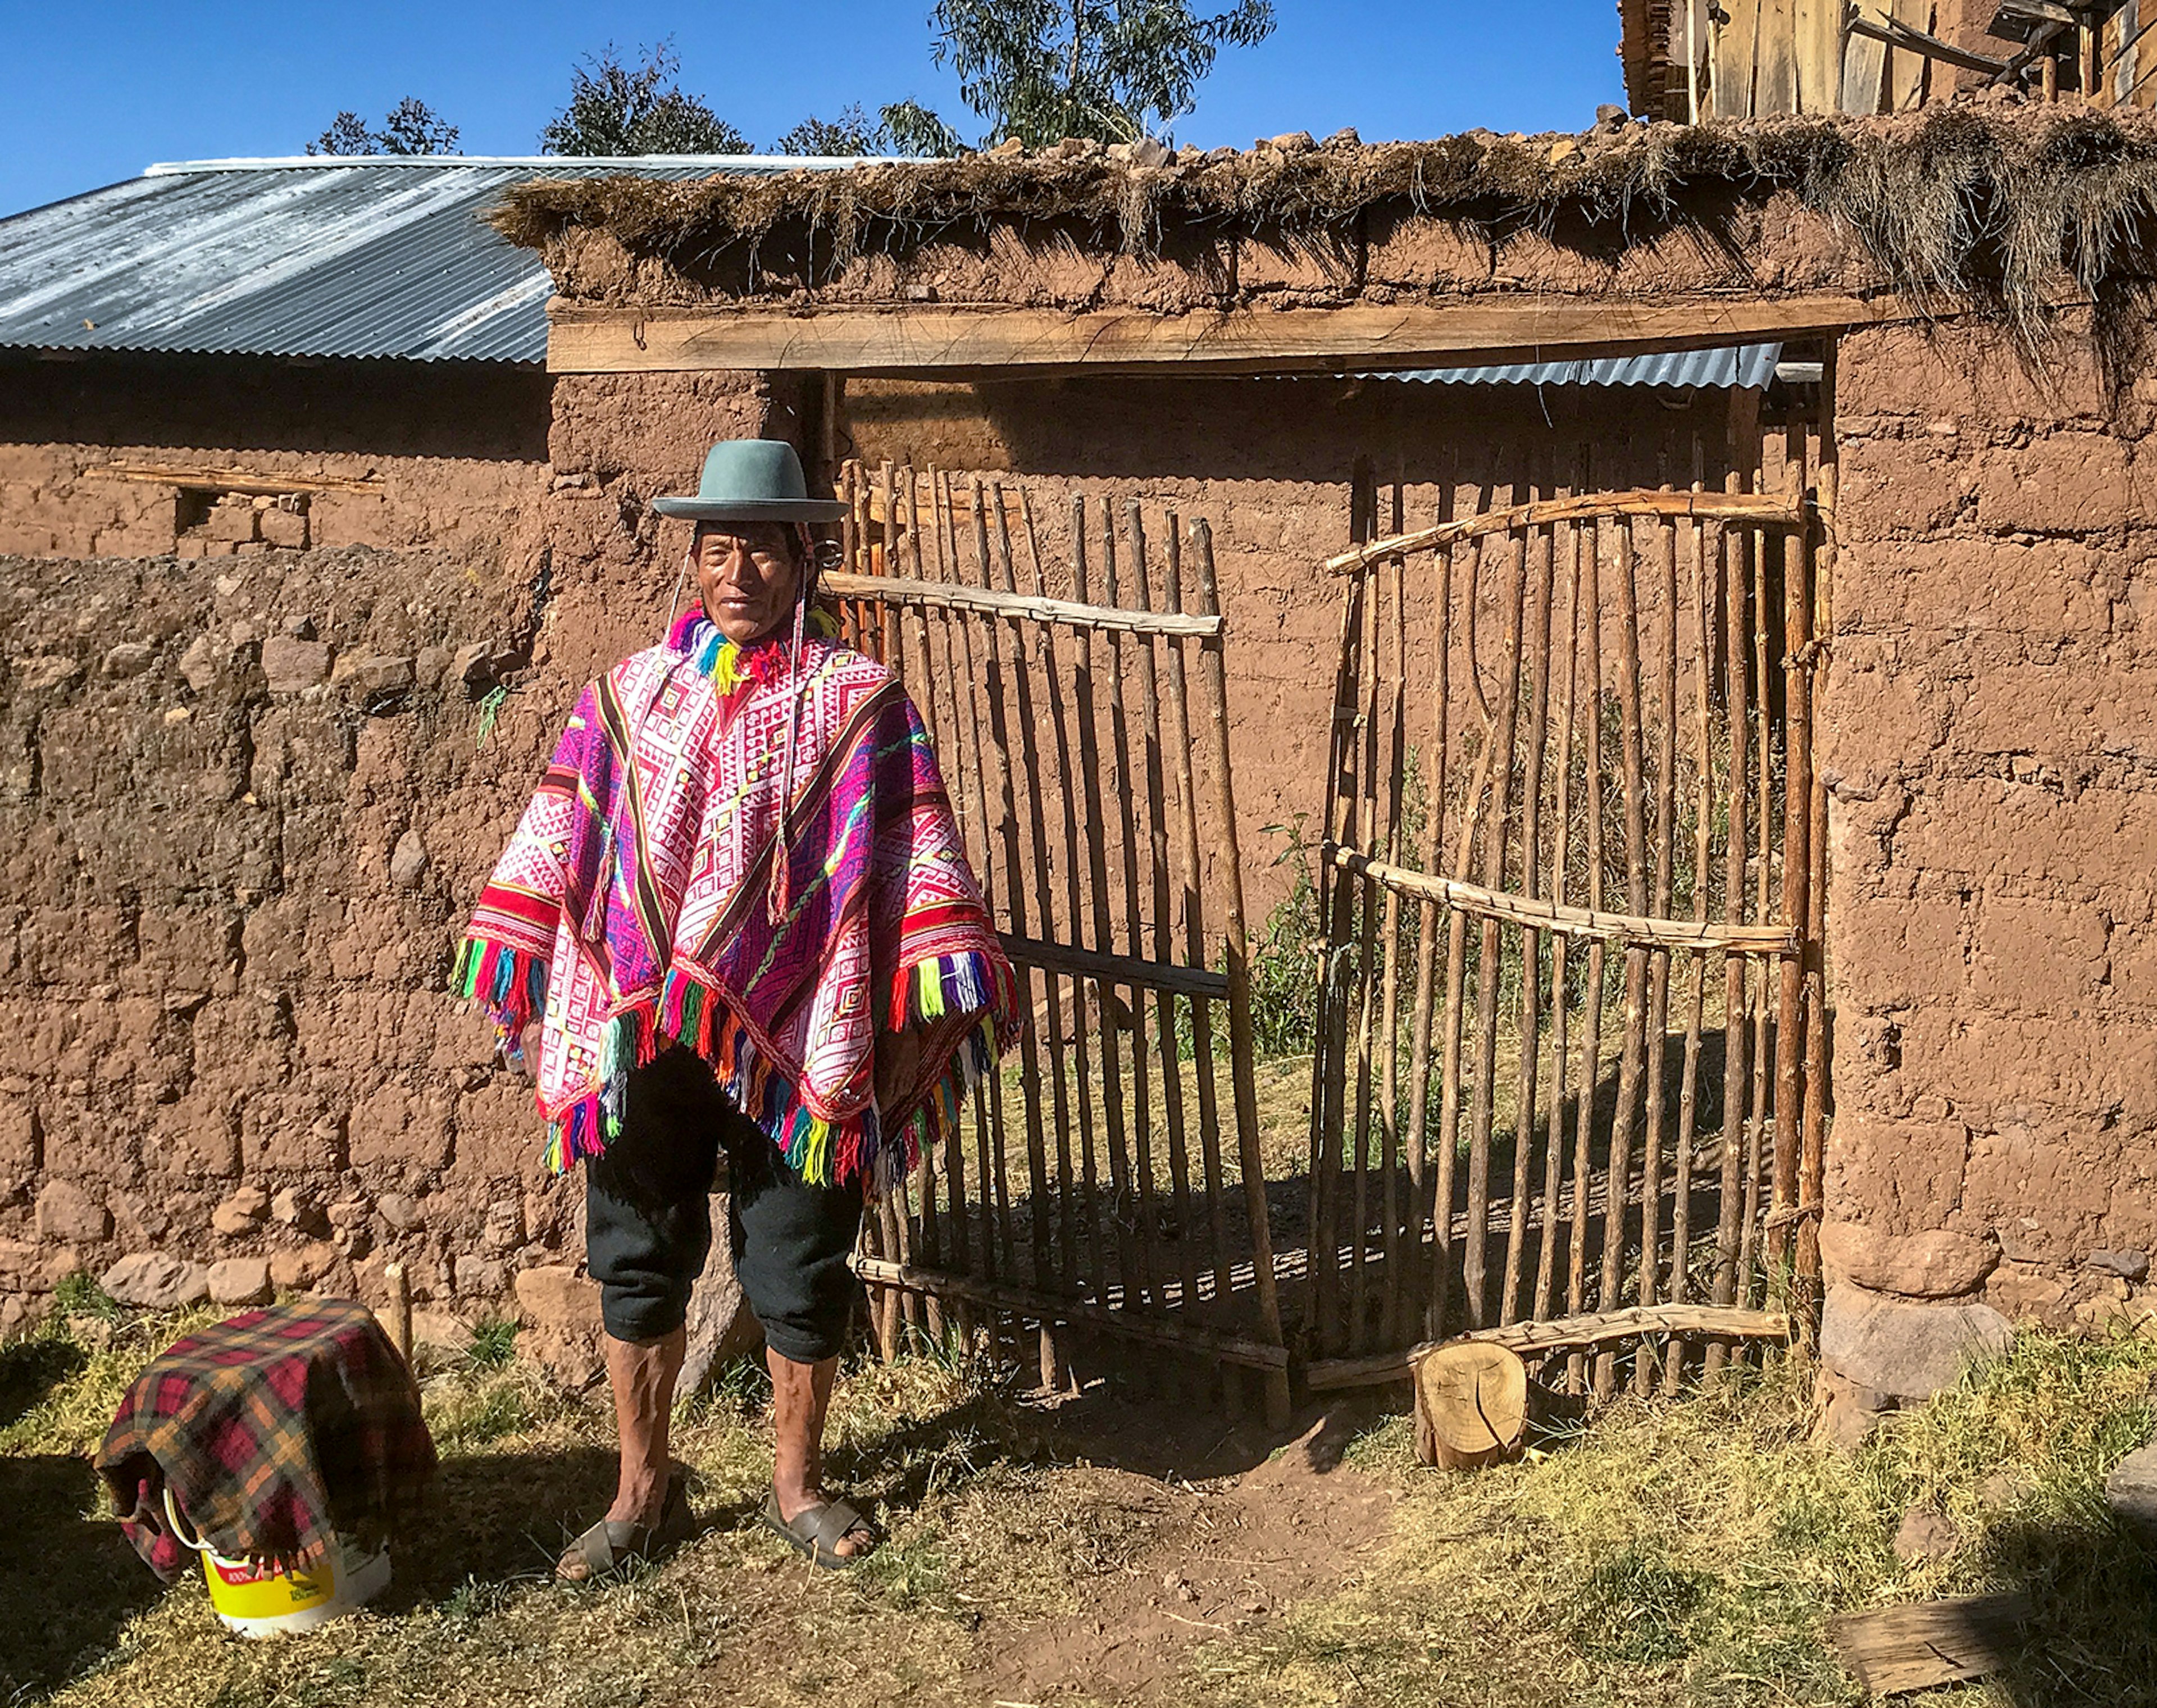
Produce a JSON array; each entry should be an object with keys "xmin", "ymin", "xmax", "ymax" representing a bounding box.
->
[{"xmin": 1309, "ymin": 457, "xmax": 1825, "ymax": 1391}]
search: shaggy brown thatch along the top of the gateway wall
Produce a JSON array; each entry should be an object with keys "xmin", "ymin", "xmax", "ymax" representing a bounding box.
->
[{"xmin": 492, "ymin": 103, "xmax": 2157, "ymax": 373}]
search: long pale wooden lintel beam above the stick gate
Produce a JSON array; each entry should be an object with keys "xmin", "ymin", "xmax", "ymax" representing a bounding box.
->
[{"xmin": 548, "ymin": 293, "xmax": 1918, "ymax": 375}]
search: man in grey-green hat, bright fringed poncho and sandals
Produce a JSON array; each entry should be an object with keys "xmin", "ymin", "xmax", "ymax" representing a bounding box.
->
[{"xmin": 457, "ymin": 440, "xmax": 1016, "ymax": 1581}]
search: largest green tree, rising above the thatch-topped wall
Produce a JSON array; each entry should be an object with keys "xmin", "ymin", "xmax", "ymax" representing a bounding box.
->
[{"xmin": 930, "ymin": 0, "xmax": 1275, "ymax": 149}]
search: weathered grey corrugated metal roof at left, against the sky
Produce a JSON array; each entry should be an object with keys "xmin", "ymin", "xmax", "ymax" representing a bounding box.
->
[{"xmin": 0, "ymin": 155, "xmax": 884, "ymax": 362}]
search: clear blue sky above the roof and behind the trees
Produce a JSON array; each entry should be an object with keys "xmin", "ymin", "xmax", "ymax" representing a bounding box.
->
[{"xmin": 0, "ymin": 0, "xmax": 1622, "ymax": 213}]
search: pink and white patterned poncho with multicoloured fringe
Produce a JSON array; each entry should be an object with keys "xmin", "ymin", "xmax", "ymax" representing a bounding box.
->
[{"xmin": 457, "ymin": 611, "xmax": 1018, "ymax": 1190}]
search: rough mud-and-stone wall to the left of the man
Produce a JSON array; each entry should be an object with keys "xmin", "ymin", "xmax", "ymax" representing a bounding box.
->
[{"xmin": 0, "ymin": 375, "xmax": 791, "ymax": 1376}]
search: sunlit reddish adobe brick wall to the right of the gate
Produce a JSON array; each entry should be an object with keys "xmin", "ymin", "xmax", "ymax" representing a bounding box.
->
[{"xmin": 1816, "ymin": 317, "xmax": 2157, "ymax": 1322}]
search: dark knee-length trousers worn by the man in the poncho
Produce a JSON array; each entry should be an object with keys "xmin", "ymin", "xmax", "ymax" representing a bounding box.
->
[{"xmin": 585, "ymin": 1048, "xmax": 861, "ymax": 1363}]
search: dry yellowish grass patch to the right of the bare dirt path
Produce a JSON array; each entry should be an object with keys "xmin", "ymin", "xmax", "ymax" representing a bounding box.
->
[{"xmin": 1191, "ymin": 1331, "xmax": 2157, "ymax": 1708}]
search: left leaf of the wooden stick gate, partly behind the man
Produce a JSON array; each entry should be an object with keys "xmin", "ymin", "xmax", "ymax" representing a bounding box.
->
[{"xmin": 826, "ymin": 464, "xmax": 1287, "ymax": 1417}]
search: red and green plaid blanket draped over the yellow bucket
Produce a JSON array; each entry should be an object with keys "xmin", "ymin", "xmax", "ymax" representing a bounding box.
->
[{"xmin": 97, "ymin": 1298, "xmax": 434, "ymax": 1579}]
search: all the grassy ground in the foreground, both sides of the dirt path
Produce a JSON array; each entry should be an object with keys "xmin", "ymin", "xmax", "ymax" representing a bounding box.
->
[{"xmin": 0, "ymin": 1315, "xmax": 2157, "ymax": 1708}]
